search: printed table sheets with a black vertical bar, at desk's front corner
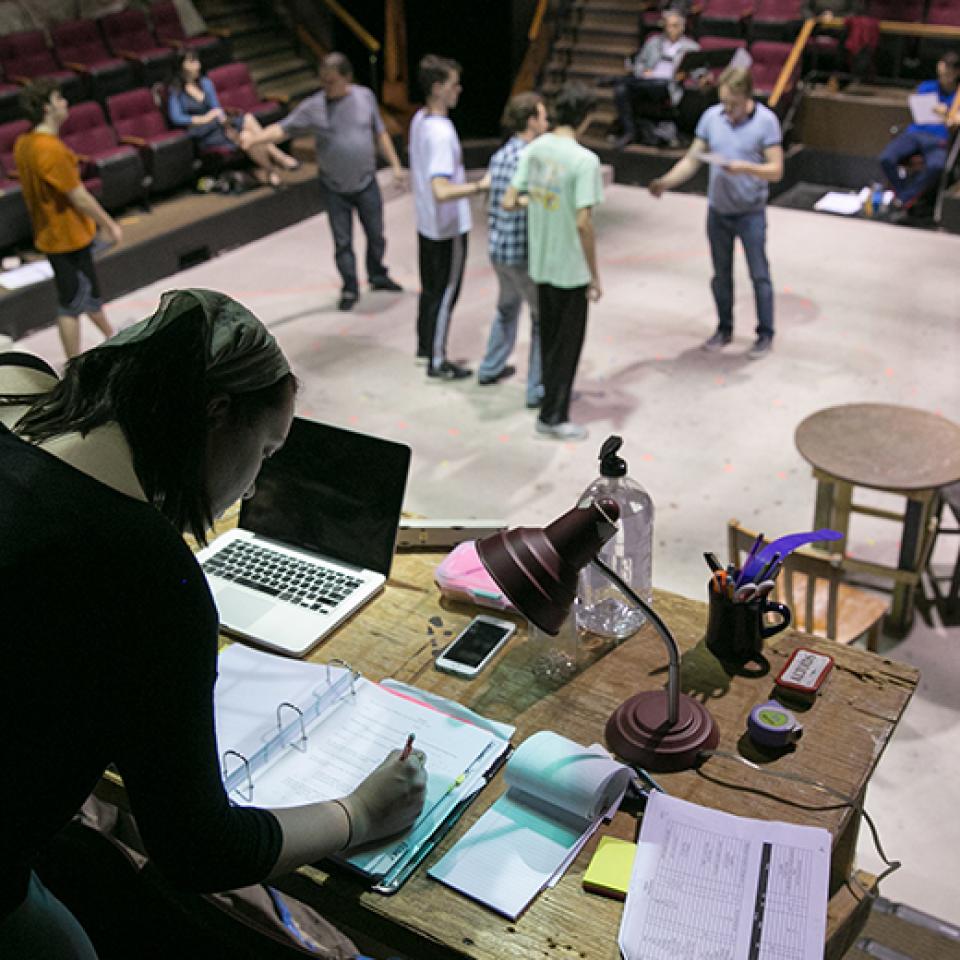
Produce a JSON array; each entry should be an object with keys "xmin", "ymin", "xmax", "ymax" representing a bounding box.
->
[{"xmin": 619, "ymin": 791, "xmax": 831, "ymax": 960}]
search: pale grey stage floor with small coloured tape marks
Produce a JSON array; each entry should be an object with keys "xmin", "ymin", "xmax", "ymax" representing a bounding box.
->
[{"xmin": 18, "ymin": 178, "xmax": 960, "ymax": 922}]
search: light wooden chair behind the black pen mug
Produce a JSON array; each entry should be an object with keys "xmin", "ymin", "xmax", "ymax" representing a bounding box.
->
[{"xmin": 727, "ymin": 520, "xmax": 888, "ymax": 651}]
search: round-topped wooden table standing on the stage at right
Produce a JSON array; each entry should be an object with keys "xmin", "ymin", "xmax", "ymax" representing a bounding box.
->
[{"xmin": 795, "ymin": 403, "xmax": 960, "ymax": 636}]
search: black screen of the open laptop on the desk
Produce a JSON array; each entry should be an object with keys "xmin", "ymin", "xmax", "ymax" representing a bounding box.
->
[{"xmin": 240, "ymin": 417, "xmax": 410, "ymax": 576}]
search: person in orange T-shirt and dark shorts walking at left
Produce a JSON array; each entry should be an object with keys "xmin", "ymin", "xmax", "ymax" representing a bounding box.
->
[{"xmin": 13, "ymin": 80, "xmax": 123, "ymax": 359}]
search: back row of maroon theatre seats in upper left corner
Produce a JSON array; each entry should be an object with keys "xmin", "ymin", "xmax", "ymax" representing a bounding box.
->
[{"xmin": 0, "ymin": 0, "xmax": 230, "ymax": 122}]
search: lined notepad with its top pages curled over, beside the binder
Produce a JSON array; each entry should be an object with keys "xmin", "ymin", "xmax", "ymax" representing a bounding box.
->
[{"xmin": 430, "ymin": 731, "xmax": 629, "ymax": 919}]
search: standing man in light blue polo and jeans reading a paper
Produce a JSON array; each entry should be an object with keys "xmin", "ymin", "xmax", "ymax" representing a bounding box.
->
[{"xmin": 649, "ymin": 67, "xmax": 783, "ymax": 360}]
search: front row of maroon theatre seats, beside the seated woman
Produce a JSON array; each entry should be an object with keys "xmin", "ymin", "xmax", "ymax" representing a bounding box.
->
[{"xmin": 0, "ymin": 63, "xmax": 284, "ymax": 255}]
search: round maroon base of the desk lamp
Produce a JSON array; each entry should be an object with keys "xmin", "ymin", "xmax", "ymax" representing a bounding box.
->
[{"xmin": 604, "ymin": 690, "xmax": 720, "ymax": 773}]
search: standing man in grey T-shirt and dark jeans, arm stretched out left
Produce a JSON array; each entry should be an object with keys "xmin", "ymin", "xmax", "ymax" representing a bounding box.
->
[{"xmin": 241, "ymin": 53, "xmax": 406, "ymax": 310}]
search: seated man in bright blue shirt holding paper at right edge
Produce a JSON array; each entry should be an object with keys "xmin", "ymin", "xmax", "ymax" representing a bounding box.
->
[{"xmin": 880, "ymin": 50, "xmax": 960, "ymax": 209}]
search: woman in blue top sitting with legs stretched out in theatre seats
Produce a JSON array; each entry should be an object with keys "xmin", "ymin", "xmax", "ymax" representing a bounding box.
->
[{"xmin": 167, "ymin": 51, "xmax": 299, "ymax": 187}]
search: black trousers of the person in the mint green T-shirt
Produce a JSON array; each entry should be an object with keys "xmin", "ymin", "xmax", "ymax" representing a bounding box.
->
[{"xmin": 537, "ymin": 283, "xmax": 587, "ymax": 425}]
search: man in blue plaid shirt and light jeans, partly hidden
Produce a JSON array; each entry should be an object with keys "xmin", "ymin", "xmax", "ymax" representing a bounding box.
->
[{"xmin": 477, "ymin": 93, "xmax": 547, "ymax": 408}]
